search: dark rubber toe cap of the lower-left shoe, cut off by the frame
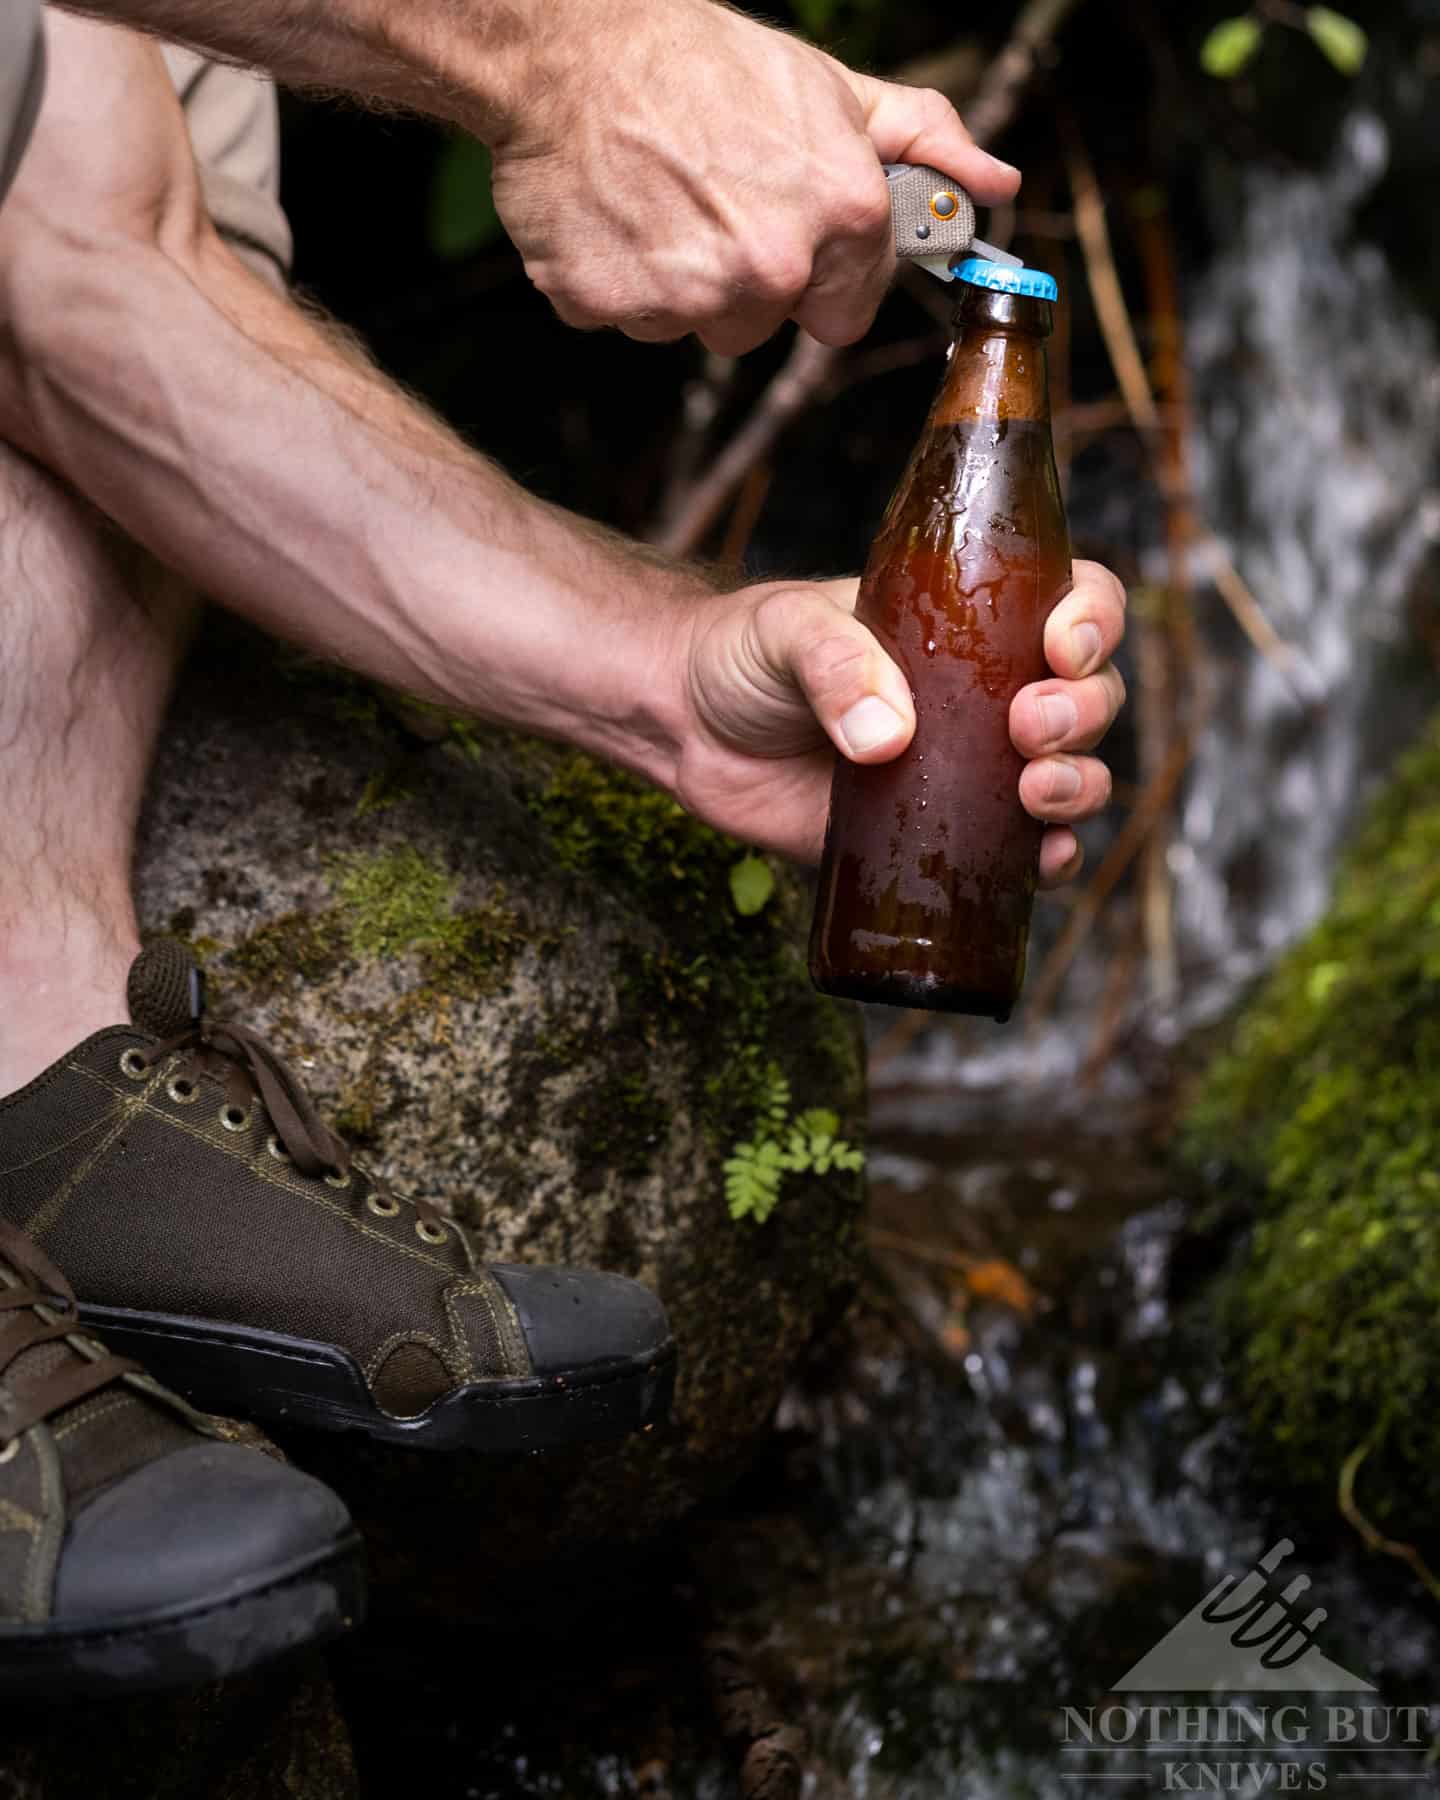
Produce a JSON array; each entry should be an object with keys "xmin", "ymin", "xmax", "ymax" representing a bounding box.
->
[{"xmin": 54, "ymin": 1442, "xmax": 351, "ymax": 1624}]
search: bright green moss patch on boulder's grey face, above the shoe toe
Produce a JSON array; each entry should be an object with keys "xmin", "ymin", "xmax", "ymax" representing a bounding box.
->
[{"xmin": 329, "ymin": 844, "xmax": 524, "ymax": 995}]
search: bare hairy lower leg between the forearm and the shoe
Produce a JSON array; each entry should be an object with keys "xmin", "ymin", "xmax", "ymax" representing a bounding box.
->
[{"xmin": 0, "ymin": 445, "xmax": 194, "ymax": 1094}]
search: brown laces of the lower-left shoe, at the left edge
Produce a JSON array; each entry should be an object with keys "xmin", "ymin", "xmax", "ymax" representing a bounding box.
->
[{"xmin": 0, "ymin": 1224, "xmax": 140, "ymax": 1456}]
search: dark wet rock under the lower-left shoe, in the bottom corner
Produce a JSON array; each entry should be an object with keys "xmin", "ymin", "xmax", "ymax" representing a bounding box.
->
[{"xmin": 0, "ymin": 1665, "xmax": 360, "ymax": 1800}]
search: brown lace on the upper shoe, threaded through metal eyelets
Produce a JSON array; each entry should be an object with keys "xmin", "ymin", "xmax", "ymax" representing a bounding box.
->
[{"xmin": 139, "ymin": 1017, "xmax": 454, "ymax": 1233}]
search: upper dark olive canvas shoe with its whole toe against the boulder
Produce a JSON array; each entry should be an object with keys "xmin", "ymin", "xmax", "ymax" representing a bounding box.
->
[{"xmin": 0, "ymin": 941, "xmax": 675, "ymax": 1451}]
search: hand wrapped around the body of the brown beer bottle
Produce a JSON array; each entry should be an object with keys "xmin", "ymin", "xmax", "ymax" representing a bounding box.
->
[{"xmin": 675, "ymin": 562, "xmax": 1125, "ymax": 887}]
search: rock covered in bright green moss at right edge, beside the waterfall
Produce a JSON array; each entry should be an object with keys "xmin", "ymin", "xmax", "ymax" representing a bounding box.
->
[{"xmin": 1184, "ymin": 720, "xmax": 1440, "ymax": 1532}]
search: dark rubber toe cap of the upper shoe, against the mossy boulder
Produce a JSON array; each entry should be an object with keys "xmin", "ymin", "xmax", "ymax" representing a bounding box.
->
[{"xmin": 490, "ymin": 1264, "xmax": 670, "ymax": 1375}]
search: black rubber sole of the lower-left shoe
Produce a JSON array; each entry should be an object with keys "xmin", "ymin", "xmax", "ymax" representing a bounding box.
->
[{"xmin": 0, "ymin": 1534, "xmax": 365, "ymax": 1699}]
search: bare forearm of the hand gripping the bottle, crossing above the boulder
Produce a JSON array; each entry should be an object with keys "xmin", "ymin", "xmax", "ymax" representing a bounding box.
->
[{"xmin": 0, "ymin": 223, "xmax": 704, "ymax": 783}]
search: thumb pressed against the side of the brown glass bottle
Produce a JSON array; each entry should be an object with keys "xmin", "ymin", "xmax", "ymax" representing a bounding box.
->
[{"xmin": 754, "ymin": 581, "xmax": 914, "ymax": 763}]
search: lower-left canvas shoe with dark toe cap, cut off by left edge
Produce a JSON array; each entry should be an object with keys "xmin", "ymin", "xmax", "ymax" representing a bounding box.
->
[{"xmin": 0, "ymin": 1224, "xmax": 364, "ymax": 1699}]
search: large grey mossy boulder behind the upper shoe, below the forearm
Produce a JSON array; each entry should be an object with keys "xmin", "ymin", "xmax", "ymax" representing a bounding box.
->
[{"xmin": 139, "ymin": 625, "xmax": 862, "ymax": 1564}]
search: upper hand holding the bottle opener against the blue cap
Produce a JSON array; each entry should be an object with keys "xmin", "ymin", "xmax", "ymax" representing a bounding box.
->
[{"xmin": 495, "ymin": 0, "xmax": 1021, "ymax": 355}]
